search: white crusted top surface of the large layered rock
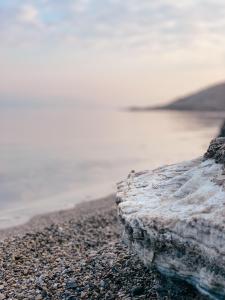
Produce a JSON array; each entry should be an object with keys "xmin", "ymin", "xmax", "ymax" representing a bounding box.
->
[{"xmin": 117, "ymin": 159, "xmax": 225, "ymax": 230}]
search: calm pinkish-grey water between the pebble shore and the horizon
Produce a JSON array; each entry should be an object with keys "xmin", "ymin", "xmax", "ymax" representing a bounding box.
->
[{"xmin": 0, "ymin": 108, "xmax": 223, "ymax": 227}]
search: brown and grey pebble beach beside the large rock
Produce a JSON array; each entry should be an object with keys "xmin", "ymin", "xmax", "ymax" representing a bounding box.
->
[{"xmin": 0, "ymin": 196, "xmax": 205, "ymax": 300}]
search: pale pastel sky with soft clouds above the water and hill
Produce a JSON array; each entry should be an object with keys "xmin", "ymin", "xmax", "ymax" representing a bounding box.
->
[{"xmin": 0, "ymin": 0, "xmax": 225, "ymax": 107}]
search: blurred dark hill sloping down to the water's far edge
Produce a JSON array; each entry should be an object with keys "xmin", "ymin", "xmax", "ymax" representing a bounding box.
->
[{"xmin": 130, "ymin": 83, "xmax": 225, "ymax": 111}]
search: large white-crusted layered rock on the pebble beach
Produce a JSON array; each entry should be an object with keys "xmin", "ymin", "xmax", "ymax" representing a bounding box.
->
[{"xmin": 117, "ymin": 138, "xmax": 225, "ymax": 299}]
